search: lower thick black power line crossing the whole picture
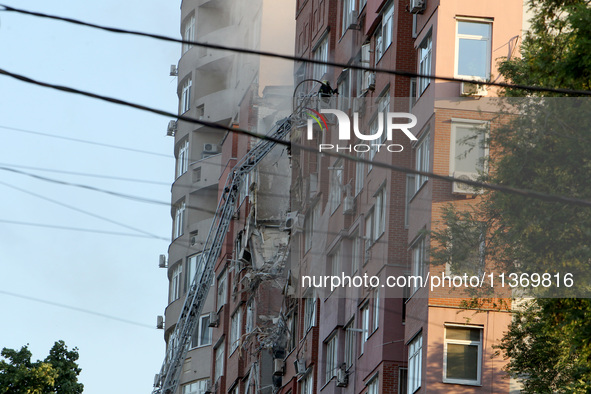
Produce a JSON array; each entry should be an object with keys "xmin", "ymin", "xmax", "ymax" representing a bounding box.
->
[{"xmin": 0, "ymin": 68, "xmax": 591, "ymax": 208}]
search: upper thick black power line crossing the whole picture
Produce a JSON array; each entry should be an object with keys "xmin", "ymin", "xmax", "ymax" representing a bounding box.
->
[{"xmin": 0, "ymin": 4, "xmax": 591, "ymax": 96}]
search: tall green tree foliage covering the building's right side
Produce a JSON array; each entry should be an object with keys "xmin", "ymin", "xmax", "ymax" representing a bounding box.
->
[{"xmin": 432, "ymin": 0, "xmax": 591, "ymax": 393}]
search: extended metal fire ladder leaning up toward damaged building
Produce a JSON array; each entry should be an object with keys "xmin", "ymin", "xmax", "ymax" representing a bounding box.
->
[{"xmin": 152, "ymin": 115, "xmax": 293, "ymax": 394}]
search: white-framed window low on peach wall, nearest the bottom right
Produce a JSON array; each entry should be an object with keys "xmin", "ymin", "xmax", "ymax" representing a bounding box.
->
[{"xmin": 443, "ymin": 325, "xmax": 482, "ymax": 384}]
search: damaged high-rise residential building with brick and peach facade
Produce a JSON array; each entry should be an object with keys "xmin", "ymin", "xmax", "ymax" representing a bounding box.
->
[{"xmin": 160, "ymin": 0, "xmax": 525, "ymax": 394}]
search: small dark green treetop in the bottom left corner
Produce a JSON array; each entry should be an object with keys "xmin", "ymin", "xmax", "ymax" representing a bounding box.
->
[{"xmin": 0, "ymin": 341, "xmax": 84, "ymax": 394}]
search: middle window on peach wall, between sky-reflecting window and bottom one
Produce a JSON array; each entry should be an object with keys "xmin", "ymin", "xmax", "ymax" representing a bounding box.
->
[{"xmin": 450, "ymin": 119, "xmax": 488, "ymax": 179}]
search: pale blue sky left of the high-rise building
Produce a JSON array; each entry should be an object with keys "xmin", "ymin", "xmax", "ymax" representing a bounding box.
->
[{"xmin": 0, "ymin": 0, "xmax": 181, "ymax": 394}]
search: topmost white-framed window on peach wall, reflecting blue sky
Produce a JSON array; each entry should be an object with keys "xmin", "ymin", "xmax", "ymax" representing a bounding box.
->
[{"xmin": 456, "ymin": 19, "xmax": 492, "ymax": 81}]
